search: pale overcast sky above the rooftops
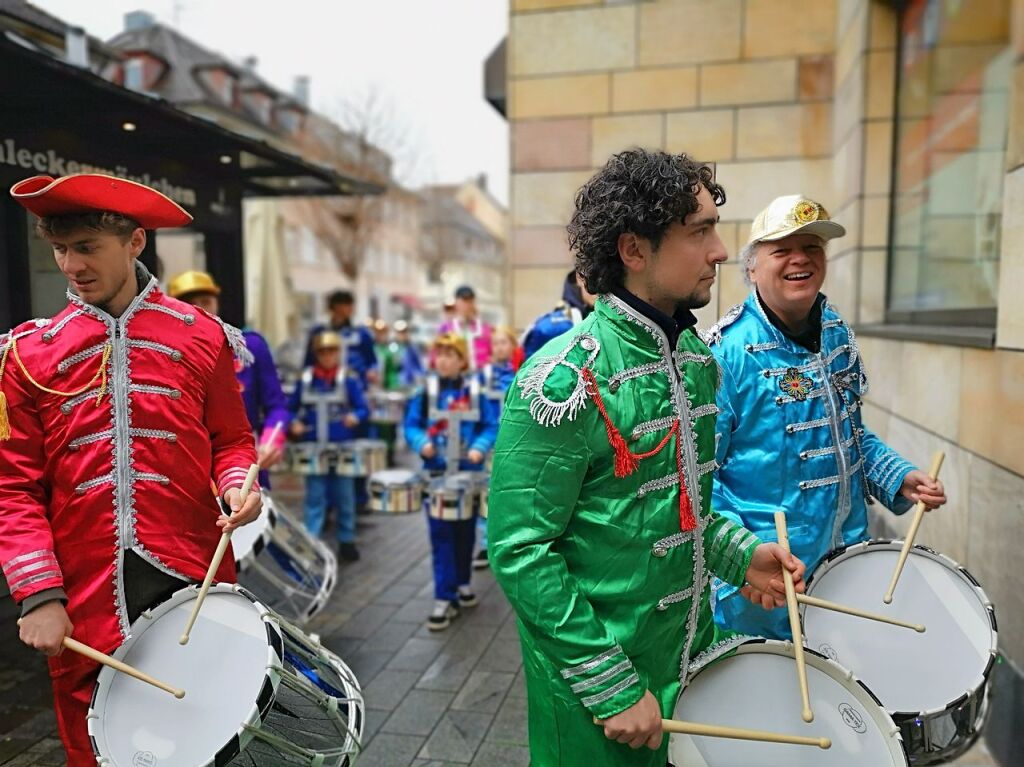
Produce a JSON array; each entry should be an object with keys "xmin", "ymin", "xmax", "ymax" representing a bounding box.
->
[{"xmin": 32, "ymin": 0, "xmax": 508, "ymax": 203}]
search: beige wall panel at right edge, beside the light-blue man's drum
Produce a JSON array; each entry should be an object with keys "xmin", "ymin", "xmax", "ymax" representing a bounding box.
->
[{"xmin": 962, "ymin": 458, "xmax": 1024, "ymax": 664}]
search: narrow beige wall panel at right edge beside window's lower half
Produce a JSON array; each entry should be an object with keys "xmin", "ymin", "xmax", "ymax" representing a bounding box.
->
[{"xmin": 995, "ymin": 167, "xmax": 1024, "ymax": 350}]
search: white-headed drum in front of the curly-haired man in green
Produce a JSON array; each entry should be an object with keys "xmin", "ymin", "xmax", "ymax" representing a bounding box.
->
[{"xmin": 669, "ymin": 637, "xmax": 907, "ymax": 767}]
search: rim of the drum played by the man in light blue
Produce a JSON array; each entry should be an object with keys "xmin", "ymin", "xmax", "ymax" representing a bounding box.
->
[{"xmin": 800, "ymin": 538, "xmax": 999, "ymax": 722}]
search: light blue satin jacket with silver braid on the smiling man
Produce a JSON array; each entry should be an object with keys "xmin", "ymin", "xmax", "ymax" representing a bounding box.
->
[{"xmin": 705, "ymin": 292, "xmax": 914, "ymax": 638}]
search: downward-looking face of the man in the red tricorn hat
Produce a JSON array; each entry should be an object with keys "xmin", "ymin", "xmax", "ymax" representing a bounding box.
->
[{"xmin": 47, "ymin": 227, "xmax": 145, "ymax": 316}]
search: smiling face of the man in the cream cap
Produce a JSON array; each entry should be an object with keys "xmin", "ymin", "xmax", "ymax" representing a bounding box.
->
[{"xmin": 751, "ymin": 235, "xmax": 825, "ymax": 318}]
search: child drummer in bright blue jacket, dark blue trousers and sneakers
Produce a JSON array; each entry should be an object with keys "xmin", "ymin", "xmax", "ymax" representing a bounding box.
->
[{"xmin": 404, "ymin": 333, "xmax": 498, "ymax": 631}]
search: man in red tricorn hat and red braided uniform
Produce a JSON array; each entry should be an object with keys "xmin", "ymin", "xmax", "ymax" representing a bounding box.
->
[{"xmin": 0, "ymin": 174, "xmax": 260, "ymax": 767}]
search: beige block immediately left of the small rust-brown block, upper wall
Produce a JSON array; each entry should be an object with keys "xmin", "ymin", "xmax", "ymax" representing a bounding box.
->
[{"xmin": 700, "ymin": 58, "xmax": 797, "ymax": 106}]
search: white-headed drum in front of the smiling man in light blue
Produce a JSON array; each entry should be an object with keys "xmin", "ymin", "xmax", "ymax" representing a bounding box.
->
[{"xmin": 801, "ymin": 541, "xmax": 997, "ymax": 765}]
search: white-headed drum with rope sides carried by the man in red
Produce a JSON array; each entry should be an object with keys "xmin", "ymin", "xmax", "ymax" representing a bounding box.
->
[{"xmin": 87, "ymin": 584, "xmax": 364, "ymax": 767}]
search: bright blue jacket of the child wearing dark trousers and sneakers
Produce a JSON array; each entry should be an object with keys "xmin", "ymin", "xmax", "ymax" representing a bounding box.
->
[{"xmin": 402, "ymin": 374, "xmax": 498, "ymax": 471}]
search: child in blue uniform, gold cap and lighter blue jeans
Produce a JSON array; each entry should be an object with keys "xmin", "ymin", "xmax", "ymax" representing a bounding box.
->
[{"xmin": 289, "ymin": 331, "xmax": 370, "ymax": 561}]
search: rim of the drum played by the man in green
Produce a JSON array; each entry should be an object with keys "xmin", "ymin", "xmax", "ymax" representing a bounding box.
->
[{"xmin": 676, "ymin": 636, "xmax": 910, "ymax": 767}]
